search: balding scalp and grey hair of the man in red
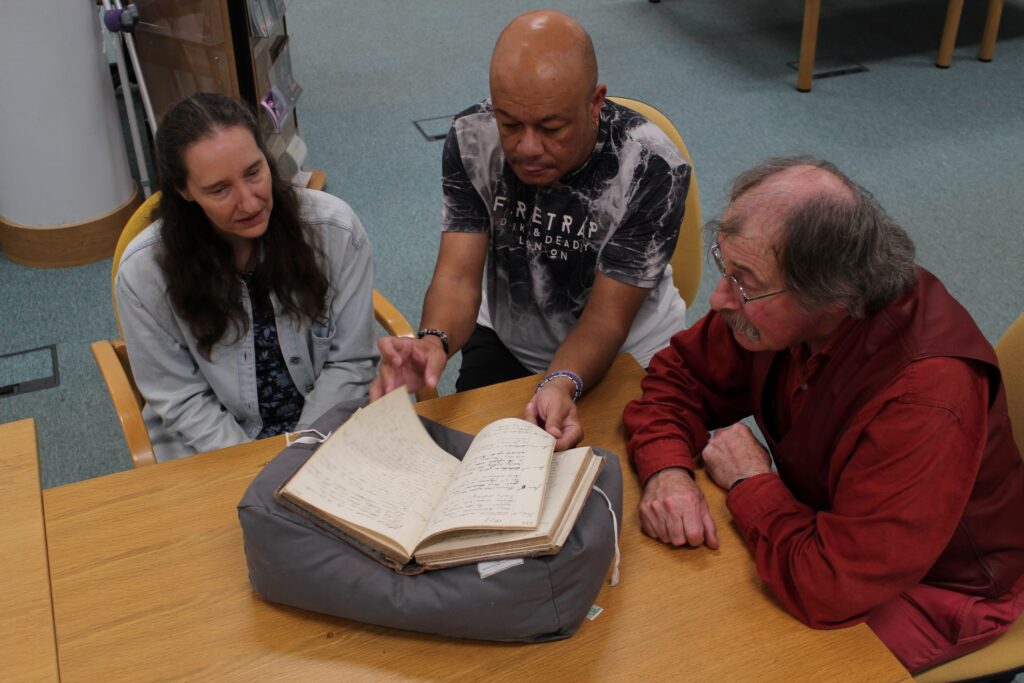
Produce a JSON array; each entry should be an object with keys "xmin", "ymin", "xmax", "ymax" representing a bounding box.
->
[{"xmin": 709, "ymin": 157, "xmax": 915, "ymax": 317}]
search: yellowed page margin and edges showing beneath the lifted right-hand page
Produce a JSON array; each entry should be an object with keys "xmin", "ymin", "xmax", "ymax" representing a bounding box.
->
[{"xmin": 416, "ymin": 447, "xmax": 592, "ymax": 561}]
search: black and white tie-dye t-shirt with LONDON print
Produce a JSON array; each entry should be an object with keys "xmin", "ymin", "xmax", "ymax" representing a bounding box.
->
[{"xmin": 441, "ymin": 100, "xmax": 690, "ymax": 372}]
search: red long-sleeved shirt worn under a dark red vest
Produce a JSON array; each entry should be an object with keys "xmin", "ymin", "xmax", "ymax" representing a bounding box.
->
[{"xmin": 624, "ymin": 313, "xmax": 1020, "ymax": 639}]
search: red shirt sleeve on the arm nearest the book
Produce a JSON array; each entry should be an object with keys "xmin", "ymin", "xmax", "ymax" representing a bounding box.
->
[{"xmin": 623, "ymin": 311, "xmax": 752, "ymax": 483}]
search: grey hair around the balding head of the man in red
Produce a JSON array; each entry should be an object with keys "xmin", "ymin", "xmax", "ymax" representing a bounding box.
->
[{"xmin": 708, "ymin": 156, "xmax": 915, "ymax": 317}]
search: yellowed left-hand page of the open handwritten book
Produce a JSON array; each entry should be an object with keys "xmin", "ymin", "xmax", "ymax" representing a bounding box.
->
[{"xmin": 284, "ymin": 388, "xmax": 459, "ymax": 555}]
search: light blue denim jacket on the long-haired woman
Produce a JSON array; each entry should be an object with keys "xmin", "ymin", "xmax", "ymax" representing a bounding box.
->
[{"xmin": 115, "ymin": 189, "xmax": 379, "ymax": 461}]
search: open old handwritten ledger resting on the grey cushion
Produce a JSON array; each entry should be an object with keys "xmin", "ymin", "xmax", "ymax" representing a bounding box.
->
[{"xmin": 278, "ymin": 389, "xmax": 604, "ymax": 570}]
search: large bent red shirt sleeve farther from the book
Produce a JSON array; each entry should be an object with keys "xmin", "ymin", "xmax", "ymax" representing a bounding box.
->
[{"xmin": 726, "ymin": 357, "xmax": 988, "ymax": 628}]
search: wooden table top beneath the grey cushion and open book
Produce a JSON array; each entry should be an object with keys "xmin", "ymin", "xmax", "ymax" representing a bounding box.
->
[{"xmin": 39, "ymin": 357, "xmax": 909, "ymax": 682}]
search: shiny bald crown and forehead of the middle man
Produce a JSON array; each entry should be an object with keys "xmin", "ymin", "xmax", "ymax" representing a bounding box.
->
[{"xmin": 490, "ymin": 9, "xmax": 597, "ymax": 96}]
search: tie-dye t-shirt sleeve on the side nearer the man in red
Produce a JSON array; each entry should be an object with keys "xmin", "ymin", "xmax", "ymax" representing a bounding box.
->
[{"xmin": 598, "ymin": 150, "xmax": 690, "ymax": 288}]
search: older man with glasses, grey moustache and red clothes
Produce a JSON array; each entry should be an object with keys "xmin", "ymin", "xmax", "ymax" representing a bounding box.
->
[{"xmin": 624, "ymin": 158, "xmax": 1024, "ymax": 672}]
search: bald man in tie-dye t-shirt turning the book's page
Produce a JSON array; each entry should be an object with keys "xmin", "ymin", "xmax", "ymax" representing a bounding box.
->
[{"xmin": 371, "ymin": 11, "xmax": 690, "ymax": 449}]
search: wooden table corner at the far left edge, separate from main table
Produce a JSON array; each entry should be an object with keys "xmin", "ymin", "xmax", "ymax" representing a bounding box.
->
[{"xmin": 0, "ymin": 420, "xmax": 58, "ymax": 681}]
